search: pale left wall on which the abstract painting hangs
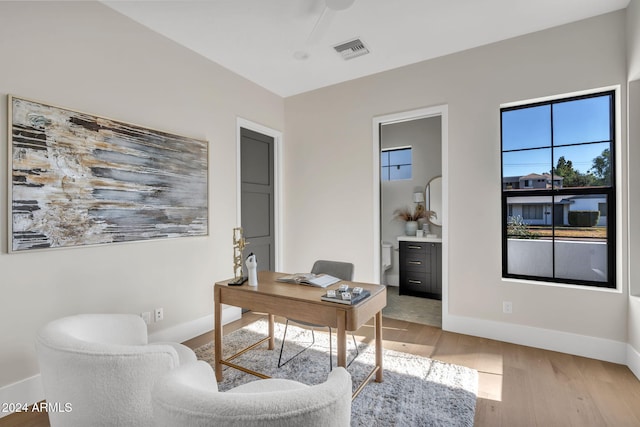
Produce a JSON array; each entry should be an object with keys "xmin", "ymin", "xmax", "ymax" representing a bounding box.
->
[{"xmin": 0, "ymin": 2, "xmax": 284, "ymax": 401}]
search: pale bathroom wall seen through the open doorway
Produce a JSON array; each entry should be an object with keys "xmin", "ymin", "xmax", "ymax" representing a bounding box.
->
[{"xmin": 380, "ymin": 116, "xmax": 442, "ymax": 286}]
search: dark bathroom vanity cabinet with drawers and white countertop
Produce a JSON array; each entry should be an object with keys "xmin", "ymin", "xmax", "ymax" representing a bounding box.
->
[{"xmin": 398, "ymin": 236, "xmax": 442, "ymax": 299}]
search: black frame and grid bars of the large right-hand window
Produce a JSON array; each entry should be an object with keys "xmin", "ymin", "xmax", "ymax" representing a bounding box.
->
[{"xmin": 500, "ymin": 88, "xmax": 619, "ymax": 289}]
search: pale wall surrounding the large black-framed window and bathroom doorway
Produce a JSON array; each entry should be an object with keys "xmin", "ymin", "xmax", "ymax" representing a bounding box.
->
[{"xmin": 284, "ymin": 11, "xmax": 628, "ymax": 361}]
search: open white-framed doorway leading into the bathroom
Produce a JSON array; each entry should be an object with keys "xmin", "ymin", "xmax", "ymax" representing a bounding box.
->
[{"xmin": 373, "ymin": 105, "xmax": 448, "ymax": 327}]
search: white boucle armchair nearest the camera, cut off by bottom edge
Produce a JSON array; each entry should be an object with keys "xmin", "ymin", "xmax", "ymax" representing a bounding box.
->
[{"xmin": 152, "ymin": 361, "xmax": 351, "ymax": 427}]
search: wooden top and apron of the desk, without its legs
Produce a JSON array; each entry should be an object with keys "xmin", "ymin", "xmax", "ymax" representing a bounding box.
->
[{"xmin": 216, "ymin": 271, "xmax": 387, "ymax": 331}]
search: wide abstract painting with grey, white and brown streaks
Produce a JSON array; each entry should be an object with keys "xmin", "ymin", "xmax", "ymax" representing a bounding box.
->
[{"xmin": 7, "ymin": 96, "xmax": 208, "ymax": 252}]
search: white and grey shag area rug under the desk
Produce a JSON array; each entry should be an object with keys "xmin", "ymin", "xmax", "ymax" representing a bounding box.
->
[{"xmin": 196, "ymin": 320, "xmax": 478, "ymax": 427}]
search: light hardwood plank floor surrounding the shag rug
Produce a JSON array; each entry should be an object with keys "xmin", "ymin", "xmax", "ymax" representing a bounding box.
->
[{"xmin": 0, "ymin": 313, "xmax": 640, "ymax": 427}]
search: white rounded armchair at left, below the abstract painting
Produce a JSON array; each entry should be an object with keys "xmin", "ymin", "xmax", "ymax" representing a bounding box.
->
[{"xmin": 36, "ymin": 314, "xmax": 196, "ymax": 427}]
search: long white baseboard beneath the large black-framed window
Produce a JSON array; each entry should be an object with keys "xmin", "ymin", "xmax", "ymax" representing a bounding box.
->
[{"xmin": 442, "ymin": 315, "xmax": 628, "ymax": 364}]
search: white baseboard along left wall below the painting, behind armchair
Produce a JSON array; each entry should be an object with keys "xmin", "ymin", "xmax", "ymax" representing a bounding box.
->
[{"xmin": 0, "ymin": 306, "xmax": 242, "ymax": 418}]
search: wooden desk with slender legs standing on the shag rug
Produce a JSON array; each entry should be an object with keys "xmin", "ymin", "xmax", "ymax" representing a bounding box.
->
[{"xmin": 214, "ymin": 271, "xmax": 387, "ymax": 395}]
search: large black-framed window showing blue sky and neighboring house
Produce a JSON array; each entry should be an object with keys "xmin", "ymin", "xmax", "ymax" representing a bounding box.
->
[{"xmin": 501, "ymin": 91, "xmax": 616, "ymax": 288}]
